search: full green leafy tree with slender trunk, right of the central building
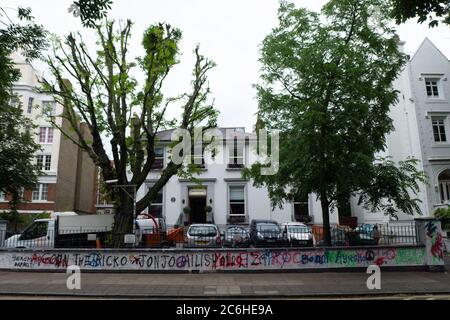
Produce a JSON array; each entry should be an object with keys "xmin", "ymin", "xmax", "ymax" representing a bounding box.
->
[{"xmin": 244, "ymin": 0, "xmax": 424, "ymax": 245}]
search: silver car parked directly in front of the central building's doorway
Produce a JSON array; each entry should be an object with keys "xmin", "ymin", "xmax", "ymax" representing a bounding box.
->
[{"xmin": 185, "ymin": 224, "xmax": 222, "ymax": 248}]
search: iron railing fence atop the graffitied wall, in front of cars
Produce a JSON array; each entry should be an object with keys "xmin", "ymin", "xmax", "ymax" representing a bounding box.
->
[{"xmin": 0, "ymin": 223, "xmax": 419, "ymax": 248}]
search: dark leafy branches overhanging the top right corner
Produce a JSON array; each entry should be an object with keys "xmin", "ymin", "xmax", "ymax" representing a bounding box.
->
[{"xmin": 392, "ymin": 0, "xmax": 450, "ymax": 27}]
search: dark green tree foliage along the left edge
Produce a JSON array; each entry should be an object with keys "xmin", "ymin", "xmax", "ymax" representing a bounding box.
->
[{"xmin": 0, "ymin": 7, "xmax": 46, "ymax": 225}]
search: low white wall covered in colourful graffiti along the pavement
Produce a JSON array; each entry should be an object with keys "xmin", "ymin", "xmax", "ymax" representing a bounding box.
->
[{"xmin": 0, "ymin": 246, "xmax": 427, "ymax": 272}]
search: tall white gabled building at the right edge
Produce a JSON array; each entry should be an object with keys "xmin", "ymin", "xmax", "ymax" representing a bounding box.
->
[{"xmin": 353, "ymin": 39, "xmax": 450, "ymax": 223}]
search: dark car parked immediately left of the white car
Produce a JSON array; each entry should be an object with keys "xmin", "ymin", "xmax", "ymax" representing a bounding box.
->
[{"xmin": 250, "ymin": 220, "xmax": 286, "ymax": 247}]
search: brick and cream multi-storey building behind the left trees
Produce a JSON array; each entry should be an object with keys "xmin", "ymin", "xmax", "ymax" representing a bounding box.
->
[{"xmin": 0, "ymin": 55, "xmax": 97, "ymax": 214}]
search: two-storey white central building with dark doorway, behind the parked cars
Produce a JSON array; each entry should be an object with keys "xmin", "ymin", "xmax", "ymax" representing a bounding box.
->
[{"xmin": 137, "ymin": 128, "xmax": 294, "ymax": 226}]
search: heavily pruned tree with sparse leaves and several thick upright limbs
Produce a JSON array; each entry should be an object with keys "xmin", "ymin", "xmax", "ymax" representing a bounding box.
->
[{"xmin": 43, "ymin": 21, "xmax": 218, "ymax": 246}]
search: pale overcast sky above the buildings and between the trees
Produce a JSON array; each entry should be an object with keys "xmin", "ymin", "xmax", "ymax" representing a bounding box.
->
[{"xmin": 0, "ymin": 0, "xmax": 450, "ymax": 130}]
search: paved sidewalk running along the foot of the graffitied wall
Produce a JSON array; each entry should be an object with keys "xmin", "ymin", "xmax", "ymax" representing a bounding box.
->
[{"xmin": 0, "ymin": 257, "xmax": 450, "ymax": 299}]
